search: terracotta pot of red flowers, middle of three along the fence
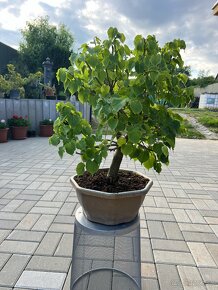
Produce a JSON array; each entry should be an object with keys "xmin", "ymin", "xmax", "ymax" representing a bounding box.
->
[{"xmin": 8, "ymin": 115, "xmax": 29, "ymax": 140}]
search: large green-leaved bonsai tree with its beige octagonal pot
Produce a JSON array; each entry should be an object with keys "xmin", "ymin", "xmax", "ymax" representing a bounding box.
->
[{"xmin": 50, "ymin": 27, "xmax": 192, "ymax": 224}]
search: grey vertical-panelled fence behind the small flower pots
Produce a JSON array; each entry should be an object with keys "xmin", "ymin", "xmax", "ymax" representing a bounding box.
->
[{"xmin": 0, "ymin": 99, "xmax": 91, "ymax": 133}]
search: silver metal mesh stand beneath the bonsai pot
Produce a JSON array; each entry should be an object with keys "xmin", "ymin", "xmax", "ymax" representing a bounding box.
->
[{"xmin": 70, "ymin": 207, "xmax": 141, "ymax": 290}]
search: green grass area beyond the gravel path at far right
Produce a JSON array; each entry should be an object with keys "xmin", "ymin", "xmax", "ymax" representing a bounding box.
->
[{"xmin": 173, "ymin": 109, "xmax": 218, "ymax": 133}]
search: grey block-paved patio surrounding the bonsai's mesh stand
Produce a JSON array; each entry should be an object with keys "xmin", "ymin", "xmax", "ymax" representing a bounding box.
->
[{"xmin": 0, "ymin": 138, "xmax": 218, "ymax": 290}]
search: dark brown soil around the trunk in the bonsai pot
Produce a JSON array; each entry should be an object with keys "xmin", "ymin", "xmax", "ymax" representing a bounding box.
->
[{"xmin": 74, "ymin": 169, "xmax": 149, "ymax": 192}]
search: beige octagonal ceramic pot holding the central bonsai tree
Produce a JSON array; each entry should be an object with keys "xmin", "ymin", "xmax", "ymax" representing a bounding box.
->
[{"xmin": 70, "ymin": 172, "xmax": 153, "ymax": 225}]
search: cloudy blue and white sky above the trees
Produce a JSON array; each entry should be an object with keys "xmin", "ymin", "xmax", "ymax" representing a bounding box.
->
[{"xmin": 0, "ymin": 0, "xmax": 218, "ymax": 77}]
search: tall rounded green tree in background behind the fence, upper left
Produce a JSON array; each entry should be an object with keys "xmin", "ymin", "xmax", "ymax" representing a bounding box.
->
[{"xmin": 19, "ymin": 16, "xmax": 74, "ymax": 73}]
